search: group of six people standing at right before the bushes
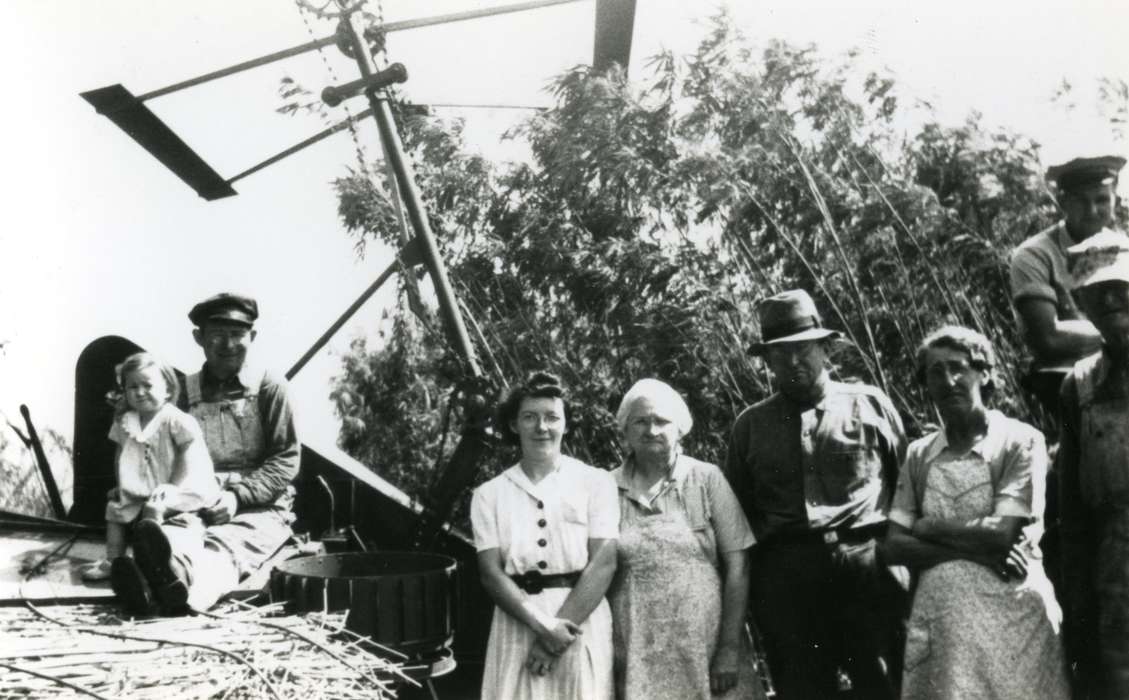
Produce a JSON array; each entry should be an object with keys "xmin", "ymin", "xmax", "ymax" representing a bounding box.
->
[{"xmin": 471, "ymin": 149, "xmax": 1129, "ymax": 700}]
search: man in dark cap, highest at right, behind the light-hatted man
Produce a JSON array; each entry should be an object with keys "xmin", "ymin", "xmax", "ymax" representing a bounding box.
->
[{"xmin": 1010, "ymin": 150, "xmax": 1126, "ymax": 406}]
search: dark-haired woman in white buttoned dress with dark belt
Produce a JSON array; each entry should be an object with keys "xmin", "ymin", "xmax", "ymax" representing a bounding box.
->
[{"xmin": 471, "ymin": 373, "xmax": 620, "ymax": 700}]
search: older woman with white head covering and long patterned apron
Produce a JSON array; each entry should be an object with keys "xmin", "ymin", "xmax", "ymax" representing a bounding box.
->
[{"xmin": 609, "ymin": 379, "xmax": 762, "ymax": 700}]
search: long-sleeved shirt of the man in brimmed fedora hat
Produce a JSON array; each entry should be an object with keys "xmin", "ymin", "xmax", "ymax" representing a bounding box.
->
[{"xmin": 726, "ymin": 380, "xmax": 905, "ymax": 542}]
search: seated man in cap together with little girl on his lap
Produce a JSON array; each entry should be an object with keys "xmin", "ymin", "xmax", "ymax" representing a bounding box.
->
[{"xmin": 82, "ymin": 294, "xmax": 300, "ymax": 615}]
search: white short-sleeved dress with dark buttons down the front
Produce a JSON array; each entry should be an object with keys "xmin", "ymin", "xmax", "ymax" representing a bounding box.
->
[{"xmin": 471, "ymin": 456, "xmax": 620, "ymax": 700}]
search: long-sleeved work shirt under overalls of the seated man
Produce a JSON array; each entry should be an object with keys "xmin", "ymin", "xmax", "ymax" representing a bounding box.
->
[{"xmin": 178, "ymin": 365, "xmax": 301, "ymax": 510}]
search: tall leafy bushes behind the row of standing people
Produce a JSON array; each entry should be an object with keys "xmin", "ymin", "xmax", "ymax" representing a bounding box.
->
[{"xmin": 322, "ymin": 15, "xmax": 1124, "ymax": 523}]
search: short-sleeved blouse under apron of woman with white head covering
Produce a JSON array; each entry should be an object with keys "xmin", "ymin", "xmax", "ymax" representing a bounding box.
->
[{"xmin": 612, "ymin": 454, "xmax": 756, "ymax": 567}]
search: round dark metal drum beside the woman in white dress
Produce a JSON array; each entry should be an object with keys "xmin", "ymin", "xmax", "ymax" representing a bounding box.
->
[{"xmin": 270, "ymin": 552, "xmax": 457, "ymax": 659}]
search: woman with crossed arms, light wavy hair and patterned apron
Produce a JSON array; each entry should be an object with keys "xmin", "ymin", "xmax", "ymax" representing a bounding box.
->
[{"xmin": 882, "ymin": 326, "xmax": 1069, "ymax": 700}]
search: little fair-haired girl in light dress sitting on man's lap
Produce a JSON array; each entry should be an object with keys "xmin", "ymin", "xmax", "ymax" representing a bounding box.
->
[{"xmin": 82, "ymin": 352, "xmax": 220, "ymax": 580}]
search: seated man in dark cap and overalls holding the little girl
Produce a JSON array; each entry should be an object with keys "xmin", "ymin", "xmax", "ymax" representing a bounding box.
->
[{"xmin": 113, "ymin": 294, "xmax": 300, "ymax": 614}]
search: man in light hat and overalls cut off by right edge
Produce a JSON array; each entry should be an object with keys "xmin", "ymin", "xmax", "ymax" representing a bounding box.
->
[{"xmin": 1058, "ymin": 231, "xmax": 1129, "ymax": 699}]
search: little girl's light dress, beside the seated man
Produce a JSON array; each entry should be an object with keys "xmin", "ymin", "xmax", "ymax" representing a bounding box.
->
[{"xmin": 106, "ymin": 403, "xmax": 220, "ymax": 523}]
